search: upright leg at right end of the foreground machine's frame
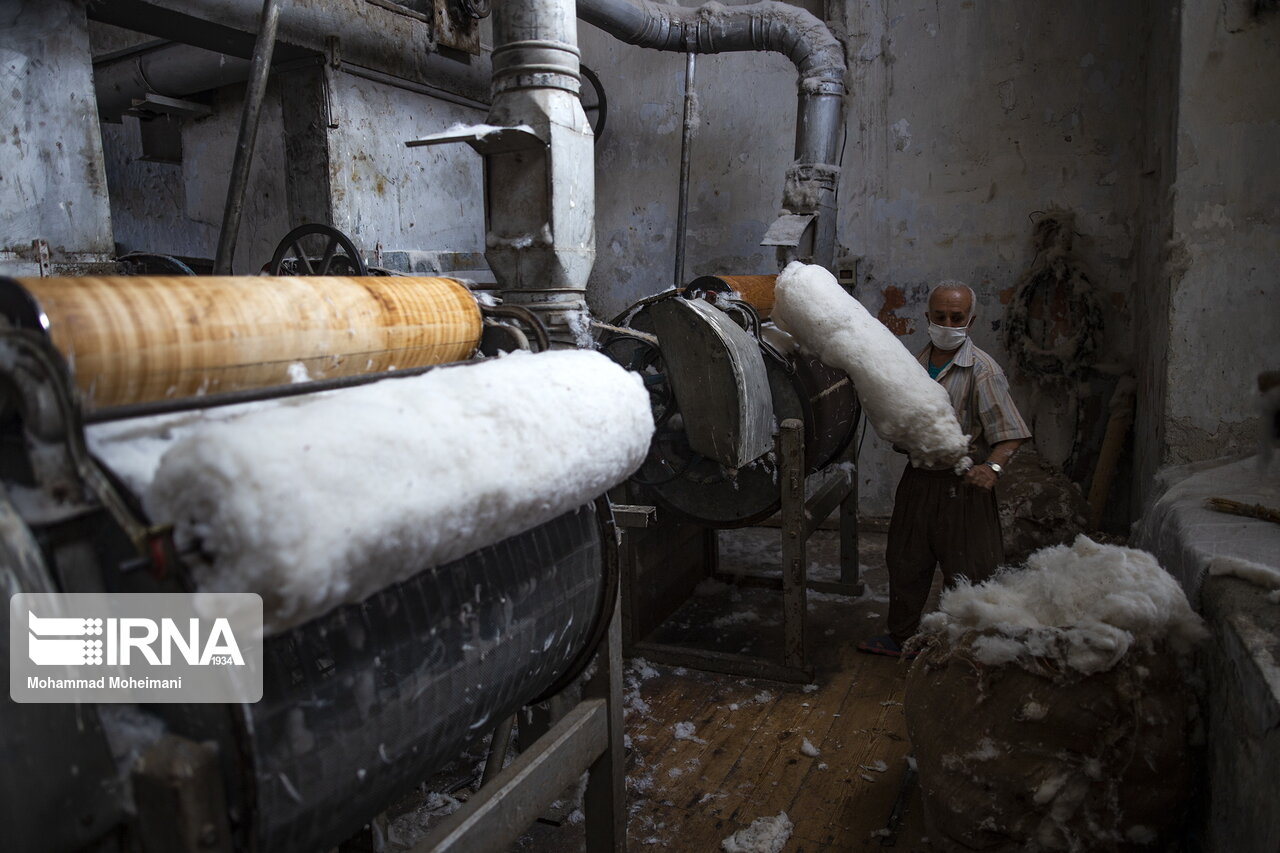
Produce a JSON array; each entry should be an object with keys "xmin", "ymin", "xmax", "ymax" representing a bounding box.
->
[{"xmin": 582, "ymin": 589, "xmax": 627, "ymax": 853}]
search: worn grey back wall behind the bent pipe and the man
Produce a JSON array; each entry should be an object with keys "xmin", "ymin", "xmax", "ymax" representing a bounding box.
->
[{"xmin": 580, "ymin": 0, "xmax": 1147, "ymax": 515}]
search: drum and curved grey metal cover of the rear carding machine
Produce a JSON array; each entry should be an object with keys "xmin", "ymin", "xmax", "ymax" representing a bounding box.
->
[{"xmin": 602, "ymin": 275, "xmax": 861, "ymax": 528}]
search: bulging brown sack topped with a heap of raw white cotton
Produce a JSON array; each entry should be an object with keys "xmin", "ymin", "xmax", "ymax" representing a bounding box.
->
[{"xmin": 905, "ymin": 535, "xmax": 1206, "ymax": 853}]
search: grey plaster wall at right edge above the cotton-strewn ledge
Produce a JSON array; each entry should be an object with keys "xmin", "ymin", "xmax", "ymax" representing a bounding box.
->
[{"xmin": 1134, "ymin": 0, "xmax": 1280, "ymax": 511}]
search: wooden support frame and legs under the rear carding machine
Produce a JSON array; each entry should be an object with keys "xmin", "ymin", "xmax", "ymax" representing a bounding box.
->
[{"xmin": 618, "ymin": 418, "xmax": 864, "ymax": 684}]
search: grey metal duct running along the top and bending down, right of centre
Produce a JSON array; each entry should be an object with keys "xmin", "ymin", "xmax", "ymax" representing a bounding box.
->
[{"xmin": 577, "ymin": 0, "xmax": 845, "ymax": 268}]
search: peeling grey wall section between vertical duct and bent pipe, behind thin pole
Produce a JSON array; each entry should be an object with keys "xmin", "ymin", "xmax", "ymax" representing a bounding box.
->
[{"xmin": 579, "ymin": 15, "xmax": 796, "ymax": 319}]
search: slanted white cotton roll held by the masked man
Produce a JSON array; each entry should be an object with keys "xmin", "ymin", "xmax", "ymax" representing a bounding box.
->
[{"xmin": 773, "ymin": 261, "xmax": 969, "ymax": 469}]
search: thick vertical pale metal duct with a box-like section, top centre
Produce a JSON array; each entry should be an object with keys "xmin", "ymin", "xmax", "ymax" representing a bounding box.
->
[{"xmin": 475, "ymin": 0, "xmax": 595, "ymax": 346}]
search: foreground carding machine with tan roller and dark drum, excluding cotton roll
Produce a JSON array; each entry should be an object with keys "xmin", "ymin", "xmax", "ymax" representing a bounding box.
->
[{"xmin": 0, "ymin": 277, "xmax": 621, "ymax": 852}]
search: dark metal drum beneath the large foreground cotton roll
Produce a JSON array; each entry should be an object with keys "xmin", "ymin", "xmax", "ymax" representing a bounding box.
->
[{"xmin": 204, "ymin": 505, "xmax": 613, "ymax": 853}]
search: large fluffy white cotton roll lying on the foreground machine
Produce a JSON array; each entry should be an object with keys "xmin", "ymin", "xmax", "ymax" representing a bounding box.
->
[{"xmin": 146, "ymin": 351, "xmax": 653, "ymax": 633}]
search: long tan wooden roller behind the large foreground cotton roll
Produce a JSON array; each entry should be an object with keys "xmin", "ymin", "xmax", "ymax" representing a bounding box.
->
[{"xmin": 6, "ymin": 275, "xmax": 481, "ymax": 409}]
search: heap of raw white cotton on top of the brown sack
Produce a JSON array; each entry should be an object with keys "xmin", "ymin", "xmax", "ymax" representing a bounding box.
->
[{"xmin": 922, "ymin": 535, "xmax": 1206, "ymax": 674}]
